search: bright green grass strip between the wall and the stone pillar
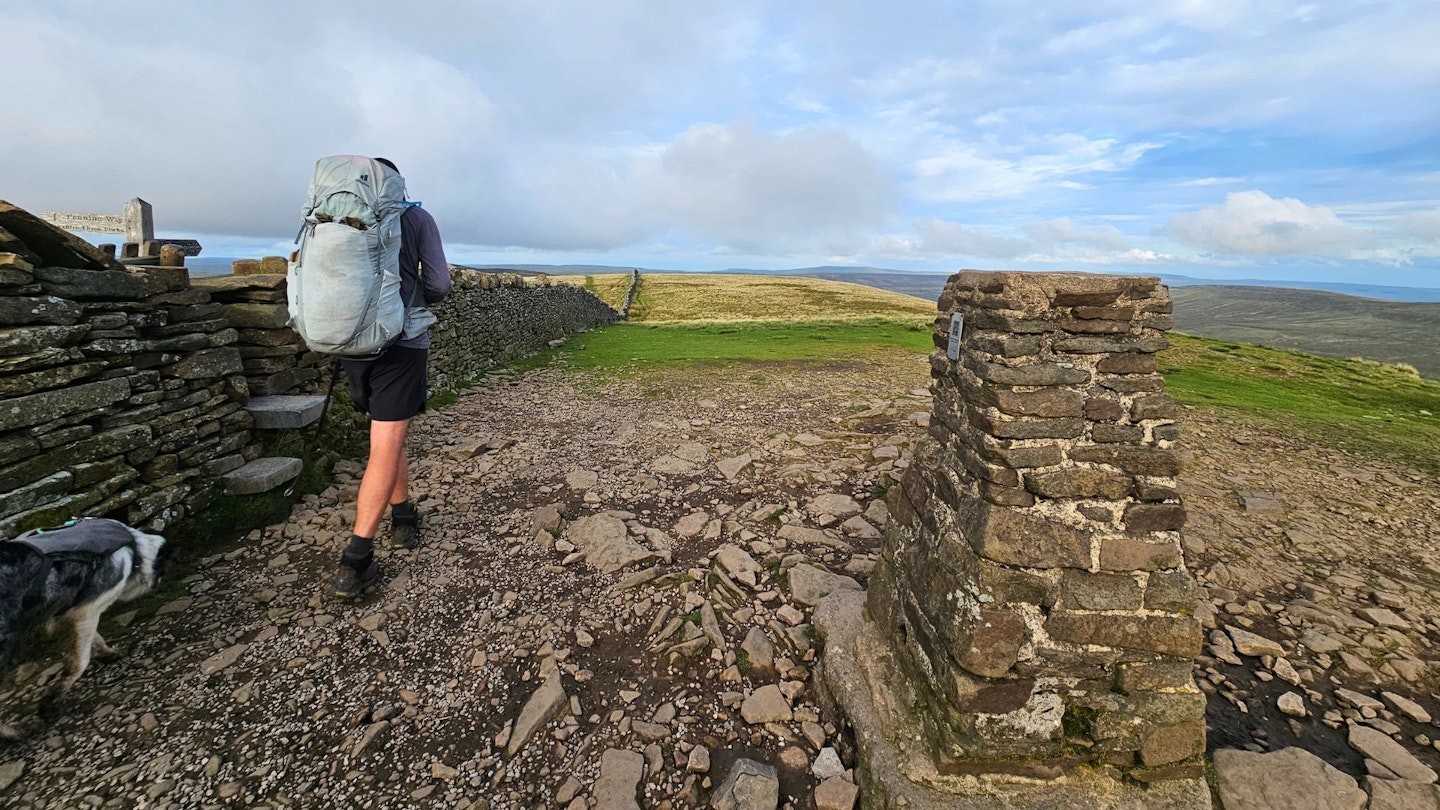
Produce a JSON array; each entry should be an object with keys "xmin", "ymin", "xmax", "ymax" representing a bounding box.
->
[{"xmin": 521, "ymin": 319, "xmax": 932, "ymax": 372}]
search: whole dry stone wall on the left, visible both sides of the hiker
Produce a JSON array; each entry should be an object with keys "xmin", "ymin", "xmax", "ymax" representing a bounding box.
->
[{"xmin": 0, "ymin": 202, "xmax": 619, "ymax": 536}]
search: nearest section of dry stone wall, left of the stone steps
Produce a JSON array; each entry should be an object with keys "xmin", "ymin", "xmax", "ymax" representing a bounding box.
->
[{"xmin": 0, "ymin": 202, "xmax": 261, "ymax": 536}]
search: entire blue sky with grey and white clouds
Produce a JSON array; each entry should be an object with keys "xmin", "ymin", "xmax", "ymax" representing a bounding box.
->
[{"xmin": 0, "ymin": 0, "xmax": 1440, "ymax": 287}]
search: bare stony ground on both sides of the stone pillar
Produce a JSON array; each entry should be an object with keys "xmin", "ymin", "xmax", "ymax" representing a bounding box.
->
[{"xmin": 0, "ymin": 348, "xmax": 1440, "ymax": 809}]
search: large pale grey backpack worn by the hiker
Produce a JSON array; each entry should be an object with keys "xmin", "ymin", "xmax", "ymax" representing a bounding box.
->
[{"xmin": 288, "ymin": 154, "xmax": 408, "ymax": 357}]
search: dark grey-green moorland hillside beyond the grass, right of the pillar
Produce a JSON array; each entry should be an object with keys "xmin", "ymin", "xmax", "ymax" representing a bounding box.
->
[{"xmin": 1171, "ymin": 285, "xmax": 1440, "ymax": 378}]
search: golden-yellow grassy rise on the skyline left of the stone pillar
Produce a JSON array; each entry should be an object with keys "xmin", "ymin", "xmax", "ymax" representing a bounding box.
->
[{"xmin": 585, "ymin": 272, "xmax": 935, "ymax": 323}]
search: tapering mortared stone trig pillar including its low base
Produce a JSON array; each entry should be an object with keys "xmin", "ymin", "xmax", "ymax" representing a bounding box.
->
[{"xmin": 816, "ymin": 271, "xmax": 1210, "ymax": 810}]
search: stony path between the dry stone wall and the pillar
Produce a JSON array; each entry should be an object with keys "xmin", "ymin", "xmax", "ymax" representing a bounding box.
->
[{"xmin": 0, "ymin": 357, "xmax": 929, "ymax": 807}]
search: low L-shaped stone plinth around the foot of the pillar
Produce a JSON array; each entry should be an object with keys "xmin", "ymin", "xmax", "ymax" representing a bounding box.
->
[{"xmin": 815, "ymin": 591, "xmax": 1215, "ymax": 810}]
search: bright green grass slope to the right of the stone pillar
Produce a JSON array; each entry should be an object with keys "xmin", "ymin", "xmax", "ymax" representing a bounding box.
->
[{"xmin": 1161, "ymin": 334, "xmax": 1440, "ymax": 474}]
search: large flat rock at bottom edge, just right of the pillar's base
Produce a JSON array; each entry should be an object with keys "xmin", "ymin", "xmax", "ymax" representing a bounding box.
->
[{"xmin": 1214, "ymin": 748, "xmax": 1365, "ymax": 810}]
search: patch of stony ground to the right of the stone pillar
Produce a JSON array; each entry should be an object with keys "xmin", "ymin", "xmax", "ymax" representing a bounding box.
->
[{"xmin": 1182, "ymin": 411, "xmax": 1440, "ymax": 809}]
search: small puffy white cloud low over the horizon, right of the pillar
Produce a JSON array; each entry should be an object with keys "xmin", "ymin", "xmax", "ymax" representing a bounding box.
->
[{"xmin": 1169, "ymin": 190, "xmax": 1369, "ymax": 257}]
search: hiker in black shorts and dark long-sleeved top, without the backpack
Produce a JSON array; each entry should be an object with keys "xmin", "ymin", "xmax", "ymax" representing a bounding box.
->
[{"xmin": 330, "ymin": 157, "xmax": 451, "ymax": 598}]
